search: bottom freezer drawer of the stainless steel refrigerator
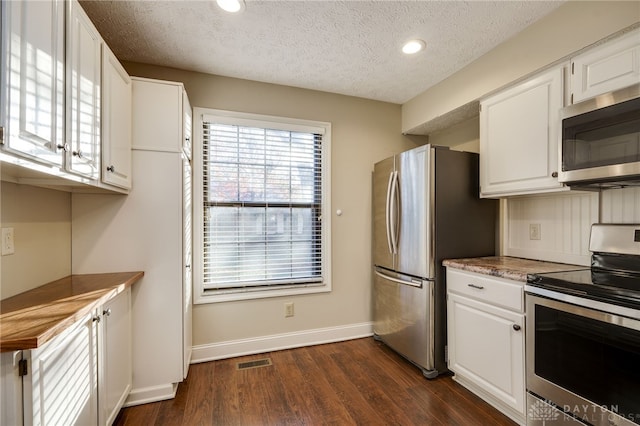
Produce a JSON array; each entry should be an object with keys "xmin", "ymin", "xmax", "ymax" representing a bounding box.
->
[{"xmin": 373, "ymin": 269, "xmax": 434, "ymax": 373}]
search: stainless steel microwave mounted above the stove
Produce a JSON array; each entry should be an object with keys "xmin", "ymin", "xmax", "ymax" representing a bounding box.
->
[{"xmin": 558, "ymin": 84, "xmax": 640, "ymax": 188}]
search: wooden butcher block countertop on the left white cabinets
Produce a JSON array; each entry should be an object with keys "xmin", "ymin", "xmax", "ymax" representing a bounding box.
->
[{"xmin": 0, "ymin": 272, "xmax": 144, "ymax": 352}]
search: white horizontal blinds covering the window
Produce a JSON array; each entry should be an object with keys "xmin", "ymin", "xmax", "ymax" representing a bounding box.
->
[{"xmin": 202, "ymin": 117, "xmax": 323, "ymax": 290}]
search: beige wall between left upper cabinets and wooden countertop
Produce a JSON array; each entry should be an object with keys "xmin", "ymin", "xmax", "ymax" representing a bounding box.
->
[{"xmin": 0, "ymin": 182, "xmax": 71, "ymax": 299}]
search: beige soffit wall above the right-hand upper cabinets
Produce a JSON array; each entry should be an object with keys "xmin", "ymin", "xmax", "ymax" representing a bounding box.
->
[{"xmin": 402, "ymin": 1, "xmax": 640, "ymax": 134}]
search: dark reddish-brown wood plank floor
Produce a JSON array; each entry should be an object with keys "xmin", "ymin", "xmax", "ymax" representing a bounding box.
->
[{"xmin": 114, "ymin": 338, "xmax": 515, "ymax": 426}]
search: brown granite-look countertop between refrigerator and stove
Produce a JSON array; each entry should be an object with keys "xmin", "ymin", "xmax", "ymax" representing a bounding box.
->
[{"xmin": 442, "ymin": 256, "xmax": 588, "ymax": 282}]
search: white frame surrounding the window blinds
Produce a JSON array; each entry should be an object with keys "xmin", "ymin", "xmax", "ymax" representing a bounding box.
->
[{"xmin": 192, "ymin": 107, "xmax": 332, "ymax": 304}]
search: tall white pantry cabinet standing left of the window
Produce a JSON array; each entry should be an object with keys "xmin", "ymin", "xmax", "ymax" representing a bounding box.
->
[{"xmin": 71, "ymin": 78, "xmax": 192, "ymax": 405}]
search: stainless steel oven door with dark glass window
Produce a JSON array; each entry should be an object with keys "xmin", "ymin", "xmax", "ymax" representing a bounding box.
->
[{"xmin": 526, "ymin": 293, "xmax": 640, "ymax": 426}]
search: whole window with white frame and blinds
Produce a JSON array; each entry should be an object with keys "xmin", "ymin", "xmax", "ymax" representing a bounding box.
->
[{"xmin": 194, "ymin": 108, "xmax": 331, "ymax": 303}]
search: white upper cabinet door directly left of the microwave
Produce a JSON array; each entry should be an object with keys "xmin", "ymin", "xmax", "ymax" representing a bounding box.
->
[{"xmin": 480, "ymin": 67, "xmax": 564, "ymax": 197}]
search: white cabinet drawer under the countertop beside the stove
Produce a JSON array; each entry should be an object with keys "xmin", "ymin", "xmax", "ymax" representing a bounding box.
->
[{"xmin": 447, "ymin": 268, "xmax": 524, "ymax": 312}]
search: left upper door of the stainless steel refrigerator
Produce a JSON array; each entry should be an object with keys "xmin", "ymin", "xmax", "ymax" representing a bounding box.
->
[{"xmin": 373, "ymin": 157, "xmax": 395, "ymax": 269}]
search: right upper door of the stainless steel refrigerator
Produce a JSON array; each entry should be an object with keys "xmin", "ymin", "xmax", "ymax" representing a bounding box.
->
[{"xmin": 392, "ymin": 145, "xmax": 434, "ymax": 279}]
